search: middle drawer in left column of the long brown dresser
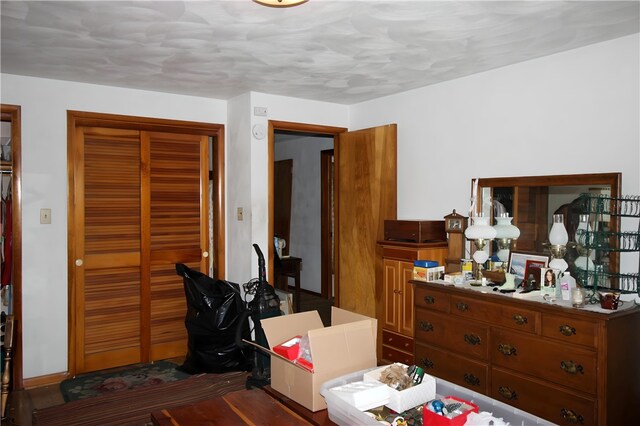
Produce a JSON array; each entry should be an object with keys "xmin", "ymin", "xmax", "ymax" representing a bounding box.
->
[{"xmin": 415, "ymin": 309, "xmax": 489, "ymax": 360}]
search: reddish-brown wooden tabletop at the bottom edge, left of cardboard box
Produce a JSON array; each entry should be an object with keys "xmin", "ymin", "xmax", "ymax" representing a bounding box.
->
[{"xmin": 151, "ymin": 389, "xmax": 318, "ymax": 426}]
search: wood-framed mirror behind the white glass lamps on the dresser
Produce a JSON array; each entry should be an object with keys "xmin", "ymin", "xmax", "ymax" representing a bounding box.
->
[{"xmin": 477, "ymin": 173, "xmax": 622, "ymax": 278}]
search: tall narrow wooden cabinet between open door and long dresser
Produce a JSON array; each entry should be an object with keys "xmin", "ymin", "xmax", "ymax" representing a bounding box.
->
[{"xmin": 376, "ymin": 241, "xmax": 447, "ymax": 365}]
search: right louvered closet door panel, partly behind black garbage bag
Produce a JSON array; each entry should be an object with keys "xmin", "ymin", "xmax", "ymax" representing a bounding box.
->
[{"xmin": 142, "ymin": 132, "xmax": 209, "ymax": 360}]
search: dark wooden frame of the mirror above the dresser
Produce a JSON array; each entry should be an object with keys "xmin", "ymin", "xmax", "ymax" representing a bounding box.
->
[{"xmin": 471, "ymin": 172, "xmax": 622, "ymax": 272}]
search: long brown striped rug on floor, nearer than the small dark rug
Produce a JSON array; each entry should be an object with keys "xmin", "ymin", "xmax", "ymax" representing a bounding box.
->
[{"xmin": 33, "ymin": 372, "xmax": 249, "ymax": 426}]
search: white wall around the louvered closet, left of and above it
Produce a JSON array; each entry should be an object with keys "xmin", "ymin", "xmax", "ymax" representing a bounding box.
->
[{"xmin": 0, "ymin": 74, "xmax": 227, "ymax": 378}]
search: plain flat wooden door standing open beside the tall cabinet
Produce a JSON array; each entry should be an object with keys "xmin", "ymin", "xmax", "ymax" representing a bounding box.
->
[{"xmin": 334, "ymin": 124, "xmax": 397, "ymax": 317}]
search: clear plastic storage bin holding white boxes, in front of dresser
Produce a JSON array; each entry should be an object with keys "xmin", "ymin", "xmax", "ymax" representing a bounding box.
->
[{"xmin": 320, "ymin": 367, "xmax": 553, "ymax": 426}]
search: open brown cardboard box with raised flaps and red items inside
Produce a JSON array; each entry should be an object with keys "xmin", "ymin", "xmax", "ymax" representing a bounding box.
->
[{"xmin": 261, "ymin": 307, "xmax": 377, "ymax": 412}]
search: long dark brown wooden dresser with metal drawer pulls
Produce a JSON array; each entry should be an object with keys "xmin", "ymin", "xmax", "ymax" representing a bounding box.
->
[{"xmin": 414, "ymin": 281, "xmax": 640, "ymax": 426}]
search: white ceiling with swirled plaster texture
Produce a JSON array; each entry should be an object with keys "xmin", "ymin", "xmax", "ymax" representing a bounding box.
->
[{"xmin": 1, "ymin": 0, "xmax": 640, "ymax": 104}]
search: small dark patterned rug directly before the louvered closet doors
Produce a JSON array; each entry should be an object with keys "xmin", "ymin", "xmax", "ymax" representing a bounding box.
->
[{"xmin": 60, "ymin": 361, "xmax": 190, "ymax": 402}]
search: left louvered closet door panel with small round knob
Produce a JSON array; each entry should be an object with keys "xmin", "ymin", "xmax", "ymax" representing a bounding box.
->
[{"xmin": 71, "ymin": 128, "xmax": 142, "ymax": 373}]
